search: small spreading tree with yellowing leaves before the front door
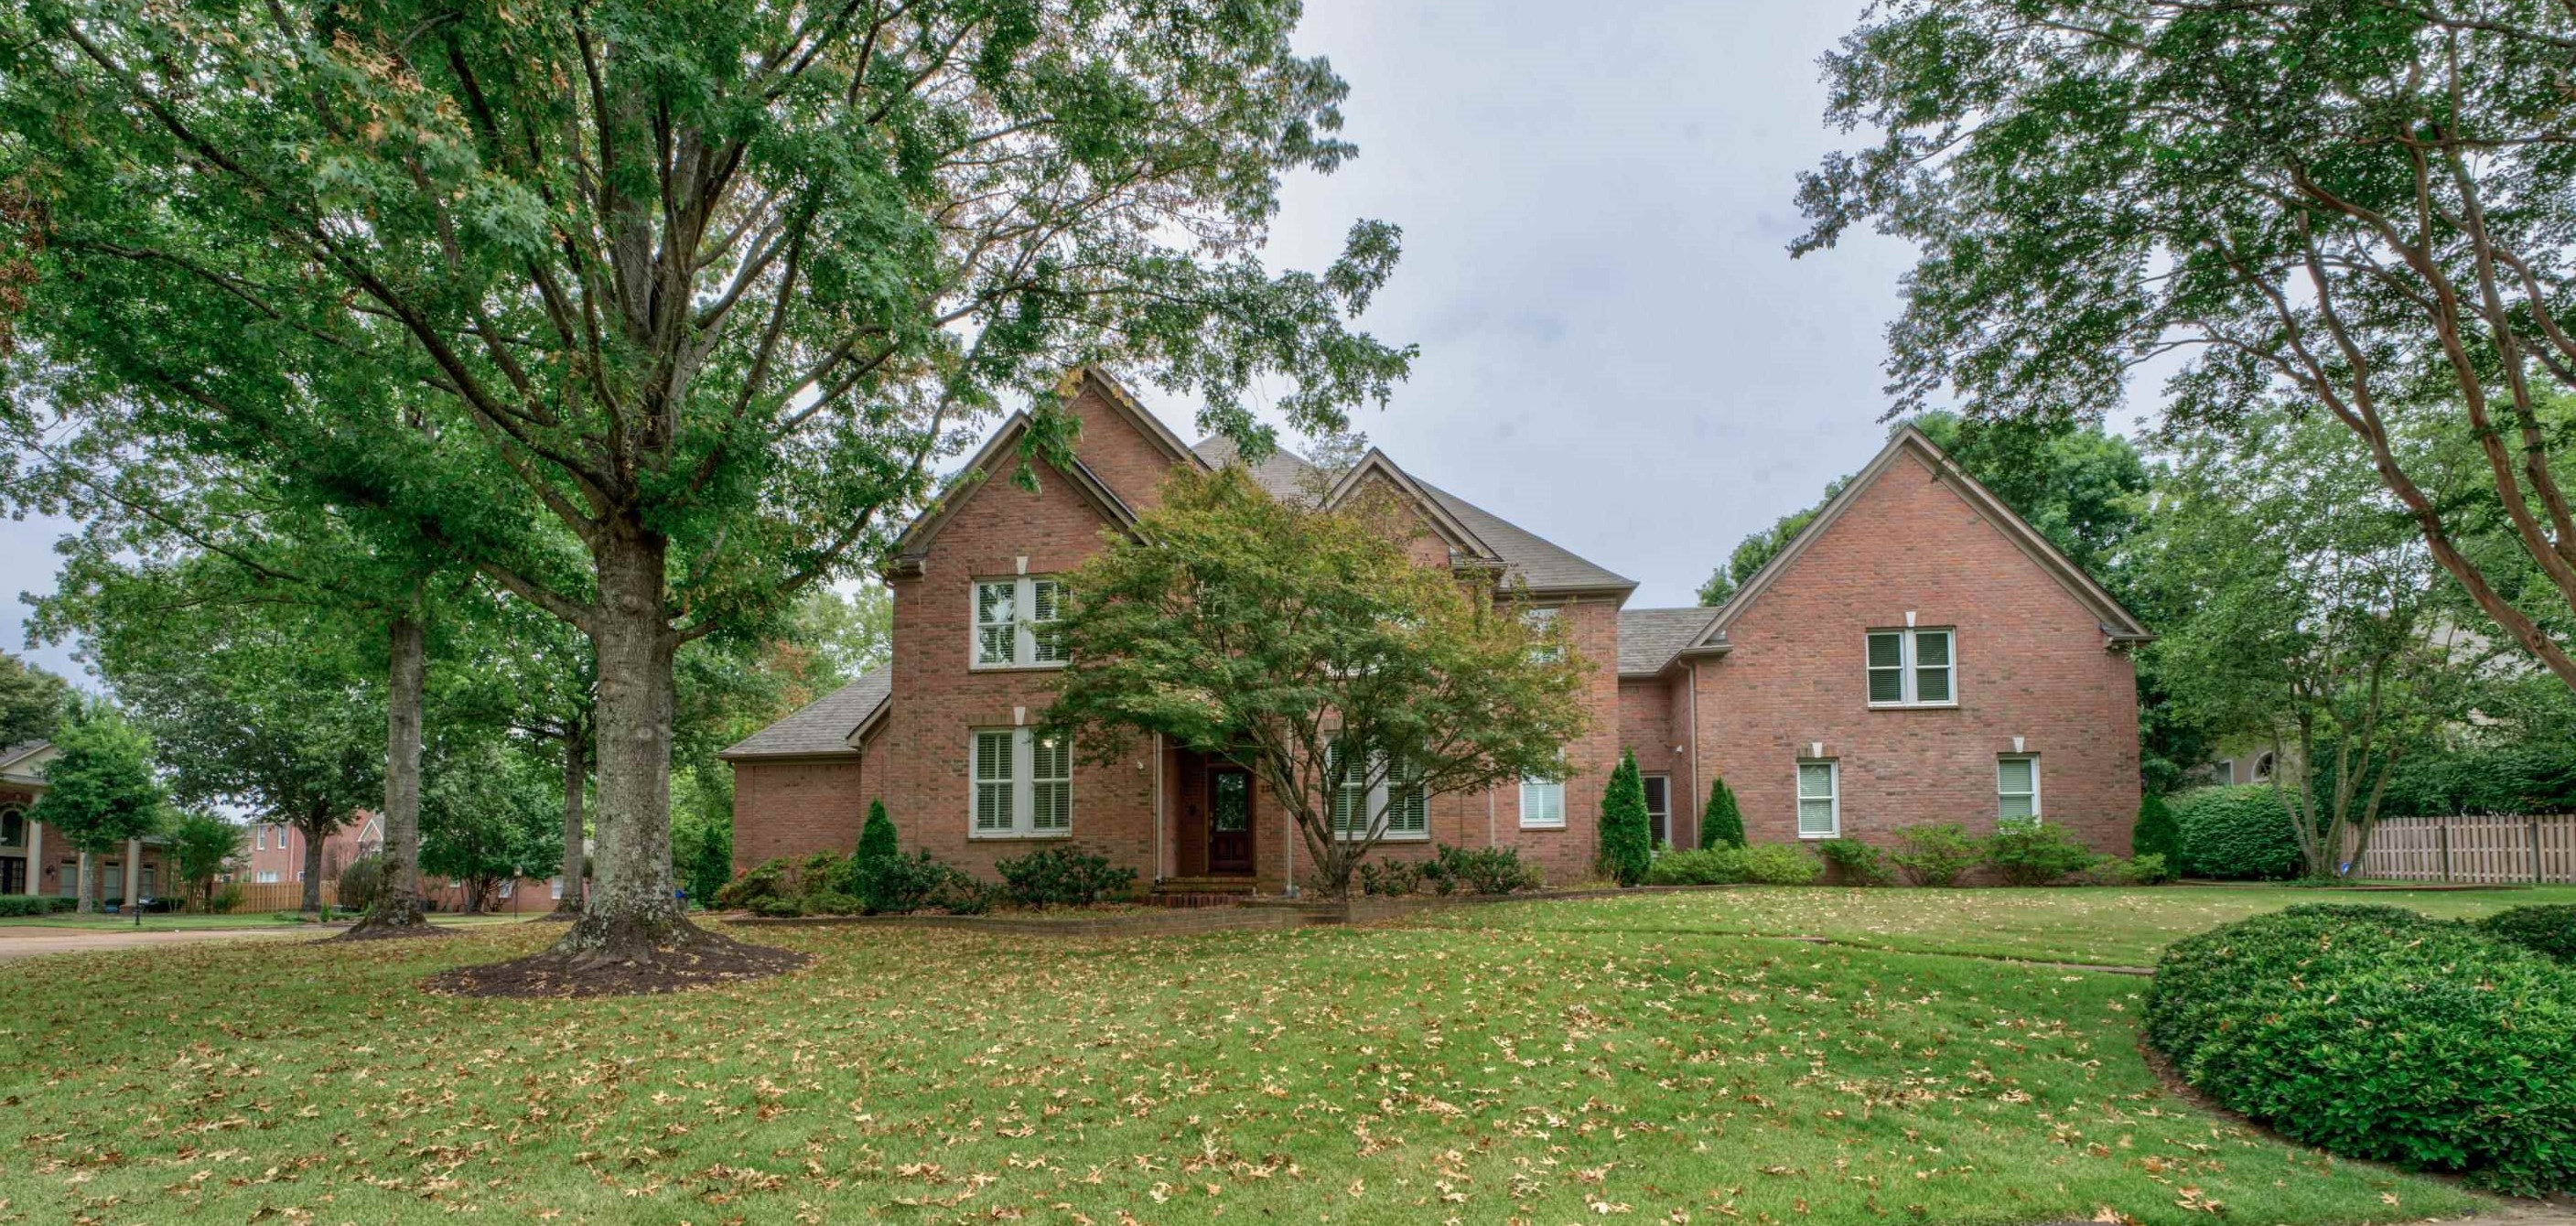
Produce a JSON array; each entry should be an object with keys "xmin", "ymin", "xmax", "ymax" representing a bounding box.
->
[{"xmin": 1046, "ymin": 467, "xmax": 1590, "ymax": 897}]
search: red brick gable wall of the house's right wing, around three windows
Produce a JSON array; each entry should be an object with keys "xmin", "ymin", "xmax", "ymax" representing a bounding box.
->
[{"xmin": 1698, "ymin": 453, "xmax": 2138, "ymax": 853}]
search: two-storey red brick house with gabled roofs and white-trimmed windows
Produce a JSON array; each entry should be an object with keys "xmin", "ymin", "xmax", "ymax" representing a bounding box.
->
[{"xmin": 721, "ymin": 369, "xmax": 2149, "ymax": 891}]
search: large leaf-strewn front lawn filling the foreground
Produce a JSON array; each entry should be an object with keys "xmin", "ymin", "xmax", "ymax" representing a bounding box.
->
[{"xmin": 0, "ymin": 891, "xmax": 2478, "ymax": 1226}]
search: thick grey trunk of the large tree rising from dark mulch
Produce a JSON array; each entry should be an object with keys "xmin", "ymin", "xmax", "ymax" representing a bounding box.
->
[{"xmin": 556, "ymin": 521, "xmax": 698, "ymax": 963}]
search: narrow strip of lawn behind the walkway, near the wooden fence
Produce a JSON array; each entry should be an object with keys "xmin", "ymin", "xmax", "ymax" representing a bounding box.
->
[{"xmin": 1432, "ymin": 886, "xmax": 2576, "ymax": 966}]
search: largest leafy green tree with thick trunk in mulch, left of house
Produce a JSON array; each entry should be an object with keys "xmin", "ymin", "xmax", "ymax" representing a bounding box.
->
[{"xmin": 0, "ymin": 0, "xmax": 1409, "ymax": 971}]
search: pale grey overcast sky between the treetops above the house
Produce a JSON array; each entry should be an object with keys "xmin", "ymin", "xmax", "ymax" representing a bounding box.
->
[{"xmin": 0, "ymin": 0, "xmax": 2081, "ymax": 675}]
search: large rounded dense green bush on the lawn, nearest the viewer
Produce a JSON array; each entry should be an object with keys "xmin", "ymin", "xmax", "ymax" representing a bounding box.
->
[{"xmin": 2146, "ymin": 904, "xmax": 2576, "ymax": 1195}]
